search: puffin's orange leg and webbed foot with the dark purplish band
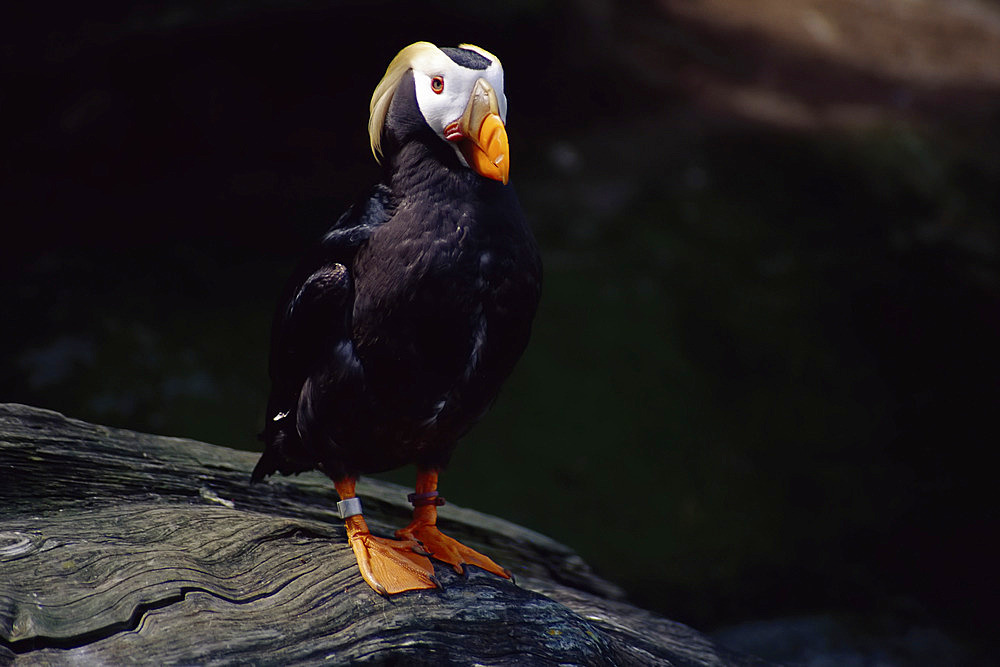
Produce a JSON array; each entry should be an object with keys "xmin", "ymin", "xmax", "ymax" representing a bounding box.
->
[{"xmin": 396, "ymin": 468, "xmax": 511, "ymax": 579}]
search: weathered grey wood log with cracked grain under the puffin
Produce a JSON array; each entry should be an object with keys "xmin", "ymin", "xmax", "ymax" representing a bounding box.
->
[{"xmin": 0, "ymin": 405, "xmax": 760, "ymax": 665}]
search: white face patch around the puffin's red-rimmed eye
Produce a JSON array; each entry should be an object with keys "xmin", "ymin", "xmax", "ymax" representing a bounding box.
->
[{"xmin": 411, "ymin": 47, "xmax": 507, "ymax": 164}]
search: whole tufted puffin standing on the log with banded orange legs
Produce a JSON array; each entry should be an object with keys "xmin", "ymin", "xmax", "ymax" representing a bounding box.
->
[{"xmin": 252, "ymin": 42, "xmax": 542, "ymax": 595}]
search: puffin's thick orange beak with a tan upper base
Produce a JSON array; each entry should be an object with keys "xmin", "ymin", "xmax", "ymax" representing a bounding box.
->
[{"xmin": 445, "ymin": 79, "xmax": 510, "ymax": 185}]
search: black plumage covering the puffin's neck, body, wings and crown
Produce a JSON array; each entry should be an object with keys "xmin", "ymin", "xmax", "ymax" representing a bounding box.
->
[{"xmin": 253, "ymin": 61, "xmax": 541, "ymax": 481}]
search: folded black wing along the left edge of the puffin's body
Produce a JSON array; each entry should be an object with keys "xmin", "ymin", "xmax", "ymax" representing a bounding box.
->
[{"xmin": 251, "ymin": 185, "xmax": 389, "ymax": 481}]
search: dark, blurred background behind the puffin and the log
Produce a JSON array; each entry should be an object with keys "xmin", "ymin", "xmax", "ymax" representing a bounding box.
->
[{"xmin": 0, "ymin": 0, "xmax": 1000, "ymax": 664}]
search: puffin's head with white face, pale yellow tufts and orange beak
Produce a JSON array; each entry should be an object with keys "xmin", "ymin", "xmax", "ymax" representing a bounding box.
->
[{"xmin": 368, "ymin": 42, "xmax": 510, "ymax": 185}]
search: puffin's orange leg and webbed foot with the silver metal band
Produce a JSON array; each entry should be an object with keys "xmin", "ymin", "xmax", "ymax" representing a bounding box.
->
[{"xmin": 334, "ymin": 477, "xmax": 439, "ymax": 595}]
